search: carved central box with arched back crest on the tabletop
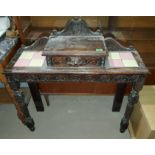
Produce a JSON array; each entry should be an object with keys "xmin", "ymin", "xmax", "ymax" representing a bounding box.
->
[{"xmin": 43, "ymin": 18, "xmax": 107, "ymax": 67}]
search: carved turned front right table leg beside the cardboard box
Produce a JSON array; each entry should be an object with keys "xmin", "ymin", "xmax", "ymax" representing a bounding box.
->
[{"xmin": 120, "ymin": 78, "xmax": 144, "ymax": 133}]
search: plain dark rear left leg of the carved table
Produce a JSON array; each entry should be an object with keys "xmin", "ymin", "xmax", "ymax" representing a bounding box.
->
[{"xmin": 28, "ymin": 82, "xmax": 44, "ymax": 111}]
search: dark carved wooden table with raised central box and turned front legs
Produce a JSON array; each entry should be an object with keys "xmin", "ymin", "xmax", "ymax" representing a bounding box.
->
[{"xmin": 5, "ymin": 19, "xmax": 148, "ymax": 132}]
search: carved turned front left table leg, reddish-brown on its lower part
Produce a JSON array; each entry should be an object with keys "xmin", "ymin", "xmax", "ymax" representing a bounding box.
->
[{"xmin": 9, "ymin": 80, "xmax": 35, "ymax": 131}]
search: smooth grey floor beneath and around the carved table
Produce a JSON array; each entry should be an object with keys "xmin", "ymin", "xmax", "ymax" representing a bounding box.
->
[{"xmin": 0, "ymin": 95, "xmax": 130, "ymax": 139}]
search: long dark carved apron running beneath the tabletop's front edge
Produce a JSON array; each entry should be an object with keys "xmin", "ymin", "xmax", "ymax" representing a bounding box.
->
[{"xmin": 7, "ymin": 73, "xmax": 146, "ymax": 83}]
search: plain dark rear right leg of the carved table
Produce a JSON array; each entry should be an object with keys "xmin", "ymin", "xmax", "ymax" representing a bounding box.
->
[{"xmin": 112, "ymin": 83, "xmax": 126, "ymax": 111}]
